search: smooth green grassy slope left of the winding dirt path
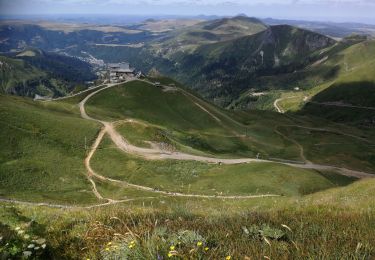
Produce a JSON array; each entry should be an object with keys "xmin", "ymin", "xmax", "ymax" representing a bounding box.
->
[{"xmin": 0, "ymin": 96, "xmax": 98, "ymax": 203}]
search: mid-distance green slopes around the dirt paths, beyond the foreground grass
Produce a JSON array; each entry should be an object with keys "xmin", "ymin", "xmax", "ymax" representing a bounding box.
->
[{"xmin": 1, "ymin": 79, "xmax": 375, "ymax": 207}]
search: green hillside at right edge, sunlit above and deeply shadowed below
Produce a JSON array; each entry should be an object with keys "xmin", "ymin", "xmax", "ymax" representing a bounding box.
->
[{"xmin": 253, "ymin": 37, "xmax": 375, "ymax": 124}]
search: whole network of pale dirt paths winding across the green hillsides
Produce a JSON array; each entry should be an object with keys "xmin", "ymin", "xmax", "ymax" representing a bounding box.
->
[{"xmin": 0, "ymin": 79, "xmax": 375, "ymax": 209}]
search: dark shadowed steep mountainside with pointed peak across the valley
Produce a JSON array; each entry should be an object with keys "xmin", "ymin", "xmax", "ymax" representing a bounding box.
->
[{"xmin": 166, "ymin": 25, "xmax": 335, "ymax": 102}]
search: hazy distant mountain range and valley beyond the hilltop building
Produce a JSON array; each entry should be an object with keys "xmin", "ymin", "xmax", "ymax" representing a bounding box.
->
[{"xmin": 0, "ymin": 15, "xmax": 375, "ymax": 121}]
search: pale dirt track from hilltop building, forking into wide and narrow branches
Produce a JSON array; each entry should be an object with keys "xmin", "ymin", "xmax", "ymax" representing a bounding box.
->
[{"xmin": 79, "ymin": 81, "xmax": 375, "ymax": 203}]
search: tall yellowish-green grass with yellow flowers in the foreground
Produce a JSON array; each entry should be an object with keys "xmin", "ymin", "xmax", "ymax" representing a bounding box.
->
[{"xmin": 0, "ymin": 180, "xmax": 375, "ymax": 259}]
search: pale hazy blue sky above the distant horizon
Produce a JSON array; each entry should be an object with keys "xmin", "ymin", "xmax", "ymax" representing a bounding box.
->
[{"xmin": 0, "ymin": 0, "xmax": 375, "ymax": 24}]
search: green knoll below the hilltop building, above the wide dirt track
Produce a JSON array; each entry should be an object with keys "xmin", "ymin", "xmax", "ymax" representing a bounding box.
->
[{"xmin": 86, "ymin": 79, "xmax": 375, "ymax": 172}]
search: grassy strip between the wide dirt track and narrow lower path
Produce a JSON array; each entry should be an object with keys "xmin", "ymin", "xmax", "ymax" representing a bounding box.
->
[{"xmin": 93, "ymin": 137, "xmax": 346, "ymax": 196}]
